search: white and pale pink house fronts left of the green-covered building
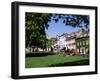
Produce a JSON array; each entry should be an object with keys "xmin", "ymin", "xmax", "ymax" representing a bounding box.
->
[{"xmin": 54, "ymin": 33, "xmax": 76, "ymax": 49}]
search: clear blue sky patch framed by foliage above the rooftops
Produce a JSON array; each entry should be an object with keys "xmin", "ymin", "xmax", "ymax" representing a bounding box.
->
[{"xmin": 46, "ymin": 20, "xmax": 79, "ymax": 37}]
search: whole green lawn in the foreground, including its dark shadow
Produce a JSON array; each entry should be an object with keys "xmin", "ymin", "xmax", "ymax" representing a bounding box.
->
[{"xmin": 25, "ymin": 54, "xmax": 89, "ymax": 68}]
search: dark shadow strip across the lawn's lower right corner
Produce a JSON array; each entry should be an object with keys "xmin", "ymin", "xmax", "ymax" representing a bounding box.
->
[{"xmin": 48, "ymin": 59, "xmax": 89, "ymax": 67}]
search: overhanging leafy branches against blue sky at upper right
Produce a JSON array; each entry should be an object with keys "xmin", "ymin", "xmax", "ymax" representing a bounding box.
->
[{"xmin": 52, "ymin": 14, "xmax": 89, "ymax": 30}]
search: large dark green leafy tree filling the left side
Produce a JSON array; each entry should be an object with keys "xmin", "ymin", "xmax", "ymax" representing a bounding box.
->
[{"xmin": 25, "ymin": 13, "xmax": 51, "ymax": 51}]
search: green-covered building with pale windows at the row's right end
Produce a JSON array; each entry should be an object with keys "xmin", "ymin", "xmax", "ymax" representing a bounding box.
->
[{"xmin": 76, "ymin": 29, "xmax": 89, "ymax": 55}]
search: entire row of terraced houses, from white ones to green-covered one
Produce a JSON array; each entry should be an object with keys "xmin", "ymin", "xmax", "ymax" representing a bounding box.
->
[{"xmin": 52, "ymin": 29, "xmax": 89, "ymax": 54}]
